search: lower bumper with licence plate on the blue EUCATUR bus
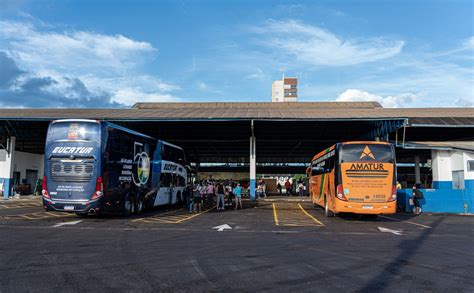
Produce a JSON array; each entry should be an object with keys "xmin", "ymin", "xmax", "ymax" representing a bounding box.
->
[{"xmin": 43, "ymin": 197, "xmax": 101, "ymax": 213}]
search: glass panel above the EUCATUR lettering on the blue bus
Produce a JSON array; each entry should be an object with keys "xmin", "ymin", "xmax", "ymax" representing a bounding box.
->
[{"xmin": 48, "ymin": 122, "xmax": 100, "ymax": 142}]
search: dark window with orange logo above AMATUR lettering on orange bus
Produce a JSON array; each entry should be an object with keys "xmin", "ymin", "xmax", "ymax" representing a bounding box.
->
[{"xmin": 340, "ymin": 144, "xmax": 395, "ymax": 163}]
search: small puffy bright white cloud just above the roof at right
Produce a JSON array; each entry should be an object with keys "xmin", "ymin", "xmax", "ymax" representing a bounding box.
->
[{"xmin": 336, "ymin": 89, "xmax": 417, "ymax": 108}]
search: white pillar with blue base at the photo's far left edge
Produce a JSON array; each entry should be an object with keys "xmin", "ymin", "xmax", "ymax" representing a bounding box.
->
[{"xmin": 0, "ymin": 136, "xmax": 16, "ymax": 199}]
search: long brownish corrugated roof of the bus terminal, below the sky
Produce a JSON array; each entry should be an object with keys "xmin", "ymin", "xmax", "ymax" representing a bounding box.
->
[{"xmin": 0, "ymin": 102, "xmax": 474, "ymax": 122}]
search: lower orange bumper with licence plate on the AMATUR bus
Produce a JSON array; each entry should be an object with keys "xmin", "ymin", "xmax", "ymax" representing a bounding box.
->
[{"xmin": 334, "ymin": 200, "xmax": 397, "ymax": 215}]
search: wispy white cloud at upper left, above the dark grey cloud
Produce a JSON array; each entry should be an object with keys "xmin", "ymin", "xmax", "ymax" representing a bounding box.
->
[{"xmin": 0, "ymin": 21, "xmax": 156, "ymax": 74}]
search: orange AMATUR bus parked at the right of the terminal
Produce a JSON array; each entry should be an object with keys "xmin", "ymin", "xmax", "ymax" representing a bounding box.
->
[{"xmin": 306, "ymin": 141, "xmax": 397, "ymax": 217}]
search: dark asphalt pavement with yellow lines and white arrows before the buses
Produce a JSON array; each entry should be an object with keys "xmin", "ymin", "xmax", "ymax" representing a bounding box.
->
[{"xmin": 0, "ymin": 198, "xmax": 474, "ymax": 292}]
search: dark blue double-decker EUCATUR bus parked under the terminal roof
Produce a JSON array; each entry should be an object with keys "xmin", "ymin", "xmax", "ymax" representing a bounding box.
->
[{"xmin": 42, "ymin": 119, "xmax": 187, "ymax": 216}]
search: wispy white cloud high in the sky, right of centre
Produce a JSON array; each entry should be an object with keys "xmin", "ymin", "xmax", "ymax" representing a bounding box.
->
[{"xmin": 253, "ymin": 20, "xmax": 404, "ymax": 66}]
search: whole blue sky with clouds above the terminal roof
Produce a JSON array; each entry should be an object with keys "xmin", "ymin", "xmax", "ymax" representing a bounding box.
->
[{"xmin": 0, "ymin": 0, "xmax": 474, "ymax": 108}]
